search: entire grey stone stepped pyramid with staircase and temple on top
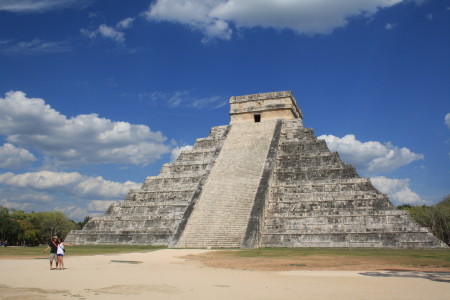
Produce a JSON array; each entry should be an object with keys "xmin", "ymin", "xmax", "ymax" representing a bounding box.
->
[{"xmin": 66, "ymin": 91, "xmax": 446, "ymax": 248}]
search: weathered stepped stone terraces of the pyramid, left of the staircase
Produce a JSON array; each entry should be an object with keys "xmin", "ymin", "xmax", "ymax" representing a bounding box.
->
[{"xmin": 66, "ymin": 126, "xmax": 232, "ymax": 245}]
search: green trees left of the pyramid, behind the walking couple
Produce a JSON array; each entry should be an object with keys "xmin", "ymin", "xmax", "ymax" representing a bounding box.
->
[{"xmin": 0, "ymin": 206, "xmax": 89, "ymax": 246}]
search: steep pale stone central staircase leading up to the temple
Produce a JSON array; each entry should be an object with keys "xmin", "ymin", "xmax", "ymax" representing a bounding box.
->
[{"xmin": 175, "ymin": 120, "xmax": 277, "ymax": 248}]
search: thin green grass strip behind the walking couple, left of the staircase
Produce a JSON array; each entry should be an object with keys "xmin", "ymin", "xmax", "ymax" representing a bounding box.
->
[{"xmin": 0, "ymin": 245, "xmax": 166, "ymax": 259}]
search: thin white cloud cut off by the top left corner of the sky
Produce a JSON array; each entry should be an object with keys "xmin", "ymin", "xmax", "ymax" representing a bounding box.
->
[{"xmin": 0, "ymin": 0, "xmax": 87, "ymax": 13}]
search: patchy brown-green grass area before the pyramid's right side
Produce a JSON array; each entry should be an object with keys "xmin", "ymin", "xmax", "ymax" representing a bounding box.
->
[{"xmin": 188, "ymin": 248, "xmax": 450, "ymax": 272}]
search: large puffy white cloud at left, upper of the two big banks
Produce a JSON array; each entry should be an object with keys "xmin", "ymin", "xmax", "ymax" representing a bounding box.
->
[{"xmin": 0, "ymin": 92, "xmax": 170, "ymax": 166}]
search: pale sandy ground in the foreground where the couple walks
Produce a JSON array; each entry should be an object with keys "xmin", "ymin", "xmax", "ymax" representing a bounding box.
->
[{"xmin": 0, "ymin": 249, "xmax": 450, "ymax": 300}]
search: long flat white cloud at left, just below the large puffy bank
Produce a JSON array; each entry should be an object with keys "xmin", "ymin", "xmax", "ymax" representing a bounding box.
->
[{"xmin": 0, "ymin": 171, "xmax": 140, "ymax": 198}]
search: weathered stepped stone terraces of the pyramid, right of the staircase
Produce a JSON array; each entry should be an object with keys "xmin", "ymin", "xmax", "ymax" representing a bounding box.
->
[{"xmin": 260, "ymin": 120, "xmax": 443, "ymax": 247}]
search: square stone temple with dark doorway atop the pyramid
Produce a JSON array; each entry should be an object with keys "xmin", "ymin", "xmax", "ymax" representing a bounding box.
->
[{"xmin": 230, "ymin": 91, "xmax": 303, "ymax": 124}]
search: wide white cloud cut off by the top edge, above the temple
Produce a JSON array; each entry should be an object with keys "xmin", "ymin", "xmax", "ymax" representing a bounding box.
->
[{"xmin": 146, "ymin": 0, "xmax": 409, "ymax": 40}]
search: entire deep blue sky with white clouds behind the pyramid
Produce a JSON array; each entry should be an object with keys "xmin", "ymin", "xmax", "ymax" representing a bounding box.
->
[{"xmin": 0, "ymin": 0, "xmax": 450, "ymax": 220}]
